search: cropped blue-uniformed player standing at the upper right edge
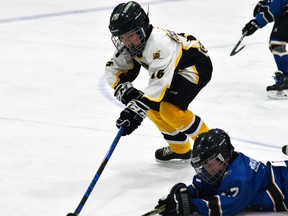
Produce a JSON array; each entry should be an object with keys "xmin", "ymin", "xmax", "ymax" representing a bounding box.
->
[{"xmin": 242, "ymin": 0, "xmax": 288, "ymax": 99}]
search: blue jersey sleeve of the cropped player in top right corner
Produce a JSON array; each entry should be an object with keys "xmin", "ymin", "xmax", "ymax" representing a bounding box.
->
[{"xmin": 253, "ymin": 0, "xmax": 288, "ymax": 28}]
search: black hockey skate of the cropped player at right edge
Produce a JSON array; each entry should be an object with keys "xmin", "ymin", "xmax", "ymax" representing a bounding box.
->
[{"xmin": 266, "ymin": 71, "xmax": 288, "ymax": 99}]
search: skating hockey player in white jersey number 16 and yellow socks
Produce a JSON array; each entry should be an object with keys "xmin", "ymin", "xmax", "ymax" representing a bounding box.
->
[{"xmin": 105, "ymin": 1, "xmax": 212, "ymax": 162}]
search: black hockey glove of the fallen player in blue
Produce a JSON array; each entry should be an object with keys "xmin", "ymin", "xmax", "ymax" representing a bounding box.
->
[{"xmin": 155, "ymin": 183, "xmax": 196, "ymax": 216}]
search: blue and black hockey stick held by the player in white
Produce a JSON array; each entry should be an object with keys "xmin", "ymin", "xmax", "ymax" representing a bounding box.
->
[{"xmin": 67, "ymin": 125, "xmax": 125, "ymax": 216}]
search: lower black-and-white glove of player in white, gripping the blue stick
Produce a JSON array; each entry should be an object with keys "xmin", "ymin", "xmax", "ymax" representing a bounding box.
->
[{"xmin": 116, "ymin": 100, "xmax": 149, "ymax": 136}]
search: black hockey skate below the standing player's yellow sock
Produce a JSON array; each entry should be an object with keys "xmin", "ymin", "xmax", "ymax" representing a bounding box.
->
[{"xmin": 155, "ymin": 146, "xmax": 191, "ymax": 163}]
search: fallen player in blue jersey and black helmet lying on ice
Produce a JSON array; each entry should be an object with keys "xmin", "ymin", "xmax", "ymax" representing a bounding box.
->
[{"xmin": 155, "ymin": 129, "xmax": 288, "ymax": 216}]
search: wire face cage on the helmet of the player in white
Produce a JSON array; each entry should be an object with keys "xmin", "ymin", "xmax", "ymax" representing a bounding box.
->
[{"xmin": 111, "ymin": 27, "xmax": 146, "ymax": 57}]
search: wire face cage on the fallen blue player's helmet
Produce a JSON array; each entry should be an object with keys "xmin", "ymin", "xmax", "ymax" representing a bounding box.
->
[{"xmin": 191, "ymin": 153, "xmax": 228, "ymax": 185}]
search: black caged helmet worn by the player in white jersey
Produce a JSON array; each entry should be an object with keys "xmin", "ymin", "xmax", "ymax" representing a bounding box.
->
[{"xmin": 109, "ymin": 1, "xmax": 149, "ymax": 57}]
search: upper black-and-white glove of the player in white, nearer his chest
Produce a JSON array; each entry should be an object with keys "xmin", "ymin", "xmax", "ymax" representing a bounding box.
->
[{"xmin": 114, "ymin": 82, "xmax": 144, "ymax": 105}]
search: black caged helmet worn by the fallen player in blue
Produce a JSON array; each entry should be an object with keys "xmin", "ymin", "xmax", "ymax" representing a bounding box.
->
[{"xmin": 191, "ymin": 128, "xmax": 234, "ymax": 184}]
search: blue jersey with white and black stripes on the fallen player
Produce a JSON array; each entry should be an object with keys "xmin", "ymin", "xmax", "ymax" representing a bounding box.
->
[{"xmin": 188, "ymin": 153, "xmax": 288, "ymax": 215}]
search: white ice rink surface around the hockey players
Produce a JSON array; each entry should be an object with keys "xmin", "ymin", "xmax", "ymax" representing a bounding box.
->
[{"xmin": 0, "ymin": 0, "xmax": 288, "ymax": 216}]
